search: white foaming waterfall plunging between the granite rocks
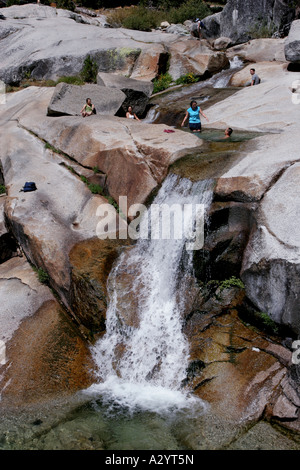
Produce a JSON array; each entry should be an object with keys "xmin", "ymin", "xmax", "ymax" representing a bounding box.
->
[{"xmin": 89, "ymin": 174, "xmax": 212, "ymax": 411}]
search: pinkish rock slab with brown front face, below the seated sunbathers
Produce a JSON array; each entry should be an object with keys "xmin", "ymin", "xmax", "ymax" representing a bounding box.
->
[{"xmin": 19, "ymin": 86, "xmax": 202, "ymax": 207}]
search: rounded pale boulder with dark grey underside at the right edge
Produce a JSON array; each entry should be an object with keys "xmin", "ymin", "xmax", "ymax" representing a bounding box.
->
[{"xmin": 242, "ymin": 163, "xmax": 300, "ymax": 334}]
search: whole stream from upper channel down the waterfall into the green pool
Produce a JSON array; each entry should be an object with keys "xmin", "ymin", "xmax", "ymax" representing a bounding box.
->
[{"xmin": 0, "ymin": 58, "xmax": 294, "ymax": 455}]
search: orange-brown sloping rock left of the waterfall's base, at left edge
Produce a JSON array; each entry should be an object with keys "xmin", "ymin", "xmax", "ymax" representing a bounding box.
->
[{"xmin": 0, "ymin": 296, "xmax": 94, "ymax": 408}]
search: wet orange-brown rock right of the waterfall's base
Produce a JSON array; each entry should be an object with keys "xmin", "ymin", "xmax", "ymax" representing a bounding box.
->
[{"xmin": 190, "ymin": 308, "xmax": 287, "ymax": 425}]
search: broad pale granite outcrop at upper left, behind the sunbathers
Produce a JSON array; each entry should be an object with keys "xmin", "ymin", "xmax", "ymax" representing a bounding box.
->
[{"xmin": 0, "ymin": 5, "xmax": 181, "ymax": 84}]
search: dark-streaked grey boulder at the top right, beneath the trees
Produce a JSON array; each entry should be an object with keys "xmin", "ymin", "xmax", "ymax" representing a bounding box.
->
[{"xmin": 203, "ymin": 0, "xmax": 295, "ymax": 44}]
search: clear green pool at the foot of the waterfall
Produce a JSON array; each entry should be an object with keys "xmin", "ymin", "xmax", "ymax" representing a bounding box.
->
[{"xmin": 0, "ymin": 395, "xmax": 300, "ymax": 455}]
